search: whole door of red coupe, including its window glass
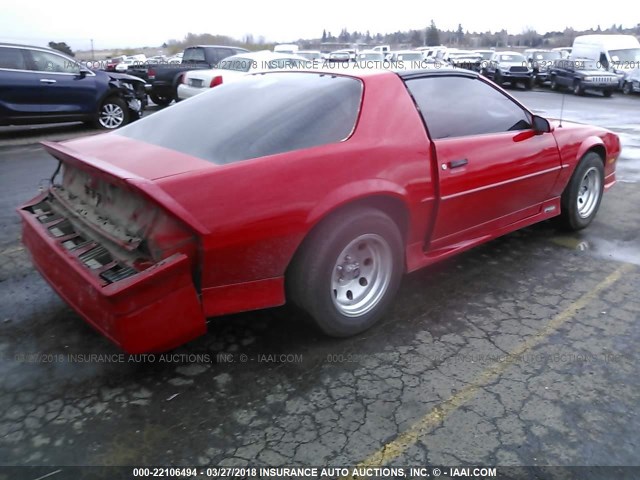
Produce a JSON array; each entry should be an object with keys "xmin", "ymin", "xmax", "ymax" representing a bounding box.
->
[{"xmin": 407, "ymin": 75, "xmax": 561, "ymax": 248}]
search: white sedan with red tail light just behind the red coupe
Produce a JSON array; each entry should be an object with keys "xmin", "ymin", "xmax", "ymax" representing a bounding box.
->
[{"xmin": 178, "ymin": 50, "xmax": 309, "ymax": 100}]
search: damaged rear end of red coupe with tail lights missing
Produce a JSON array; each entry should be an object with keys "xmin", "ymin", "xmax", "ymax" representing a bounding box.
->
[{"xmin": 19, "ymin": 143, "xmax": 206, "ymax": 353}]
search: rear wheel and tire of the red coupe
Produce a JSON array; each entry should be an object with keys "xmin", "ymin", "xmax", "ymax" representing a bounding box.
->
[{"xmin": 287, "ymin": 208, "xmax": 404, "ymax": 337}]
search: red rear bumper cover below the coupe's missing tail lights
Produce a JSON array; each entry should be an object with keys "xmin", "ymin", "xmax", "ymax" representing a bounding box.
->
[{"xmin": 20, "ymin": 194, "xmax": 206, "ymax": 353}]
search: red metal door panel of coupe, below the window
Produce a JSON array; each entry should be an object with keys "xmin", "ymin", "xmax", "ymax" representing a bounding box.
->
[{"xmin": 431, "ymin": 131, "xmax": 561, "ymax": 248}]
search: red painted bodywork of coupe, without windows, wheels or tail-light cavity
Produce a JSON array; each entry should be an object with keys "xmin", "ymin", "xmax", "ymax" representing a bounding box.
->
[{"xmin": 21, "ymin": 72, "xmax": 620, "ymax": 352}]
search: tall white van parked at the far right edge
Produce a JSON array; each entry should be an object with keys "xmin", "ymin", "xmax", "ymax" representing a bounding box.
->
[{"xmin": 571, "ymin": 35, "xmax": 640, "ymax": 73}]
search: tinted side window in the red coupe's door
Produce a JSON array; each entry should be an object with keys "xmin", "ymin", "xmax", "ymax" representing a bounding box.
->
[{"xmin": 407, "ymin": 76, "xmax": 531, "ymax": 140}]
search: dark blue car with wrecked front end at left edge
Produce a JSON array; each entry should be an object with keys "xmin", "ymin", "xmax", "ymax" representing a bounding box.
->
[{"xmin": 0, "ymin": 43, "xmax": 146, "ymax": 130}]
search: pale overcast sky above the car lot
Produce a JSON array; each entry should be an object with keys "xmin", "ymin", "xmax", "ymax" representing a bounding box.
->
[{"xmin": 0, "ymin": 0, "xmax": 638, "ymax": 50}]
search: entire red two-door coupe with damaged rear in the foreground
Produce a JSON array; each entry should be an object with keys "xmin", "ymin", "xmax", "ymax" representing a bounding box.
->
[{"xmin": 20, "ymin": 70, "xmax": 620, "ymax": 353}]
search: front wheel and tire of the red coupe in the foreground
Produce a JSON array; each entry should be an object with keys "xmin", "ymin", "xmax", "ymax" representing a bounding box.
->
[{"xmin": 560, "ymin": 152, "xmax": 604, "ymax": 231}]
